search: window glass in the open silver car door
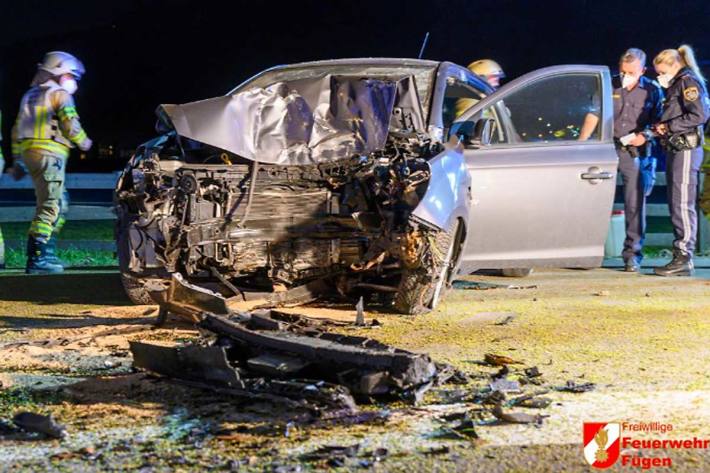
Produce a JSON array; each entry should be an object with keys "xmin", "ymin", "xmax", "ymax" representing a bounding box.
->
[{"xmin": 483, "ymin": 74, "xmax": 602, "ymax": 144}]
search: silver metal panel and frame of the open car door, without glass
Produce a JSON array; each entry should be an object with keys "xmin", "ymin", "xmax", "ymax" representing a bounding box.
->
[{"xmin": 457, "ymin": 66, "xmax": 618, "ymax": 272}]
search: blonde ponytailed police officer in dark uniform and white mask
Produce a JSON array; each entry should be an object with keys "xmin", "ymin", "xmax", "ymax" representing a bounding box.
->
[{"xmin": 653, "ymin": 45, "xmax": 710, "ymax": 276}]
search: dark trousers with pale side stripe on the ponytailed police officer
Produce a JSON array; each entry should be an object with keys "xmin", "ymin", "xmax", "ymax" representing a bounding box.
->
[{"xmin": 666, "ymin": 147, "xmax": 703, "ymax": 254}]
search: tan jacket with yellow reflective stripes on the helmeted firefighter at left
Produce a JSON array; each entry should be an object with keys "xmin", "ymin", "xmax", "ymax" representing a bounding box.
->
[{"xmin": 12, "ymin": 80, "xmax": 88, "ymax": 156}]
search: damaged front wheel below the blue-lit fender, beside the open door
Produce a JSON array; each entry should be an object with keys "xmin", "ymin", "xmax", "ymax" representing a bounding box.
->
[{"xmin": 394, "ymin": 220, "xmax": 461, "ymax": 315}]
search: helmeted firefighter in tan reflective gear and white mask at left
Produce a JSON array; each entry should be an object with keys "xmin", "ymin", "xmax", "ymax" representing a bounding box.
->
[{"xmin": 12, "ymin": 51, "xmax": 91, "ymax": 274}]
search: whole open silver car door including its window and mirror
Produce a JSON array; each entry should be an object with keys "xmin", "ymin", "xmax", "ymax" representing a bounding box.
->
[{"xmin": 450, "ymin": 65, "xmax": 617, "ymax": 272}]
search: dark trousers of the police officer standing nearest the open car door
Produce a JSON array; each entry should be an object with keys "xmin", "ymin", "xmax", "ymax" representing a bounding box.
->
[{"xmin": 616, "ymin": 148, "xmax": 646, "ymax": 261}]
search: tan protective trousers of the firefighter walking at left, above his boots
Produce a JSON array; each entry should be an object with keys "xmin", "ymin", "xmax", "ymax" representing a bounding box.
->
[{"xmin": 22, "ymin": 148, "xmax": 69, "ymax": 243}]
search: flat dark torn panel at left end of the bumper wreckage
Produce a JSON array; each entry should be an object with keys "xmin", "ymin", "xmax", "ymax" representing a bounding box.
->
[{"xmin": 130, "ymin": 341, "xmax": 244, "ymax": 388}]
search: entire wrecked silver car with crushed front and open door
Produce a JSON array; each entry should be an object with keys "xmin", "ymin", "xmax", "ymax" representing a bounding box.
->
[{"xmin": 116, "ymin": 59, "xmax": 616, "ymax": 314}]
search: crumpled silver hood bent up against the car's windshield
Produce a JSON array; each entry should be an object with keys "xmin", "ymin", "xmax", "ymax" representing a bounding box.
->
[{"xmin": 157, "ymin": 75, "xmax": 424, "ymax": 165}]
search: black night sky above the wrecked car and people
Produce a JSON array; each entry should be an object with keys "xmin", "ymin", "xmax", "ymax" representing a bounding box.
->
[{"xmin": 0, "ymin": 0, "xmax": 710, "ymax": 168}]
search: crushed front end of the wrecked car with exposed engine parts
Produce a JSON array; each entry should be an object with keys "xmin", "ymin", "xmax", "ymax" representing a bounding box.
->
[{"xmin": 116, "ymin": 63, "xmax": 468, "ymax": 314}]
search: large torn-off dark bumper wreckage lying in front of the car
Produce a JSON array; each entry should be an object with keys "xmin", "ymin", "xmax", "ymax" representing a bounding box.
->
[{"xmin": 130, "ymin": 288, "xmax": 457, "ymax": 418}]
